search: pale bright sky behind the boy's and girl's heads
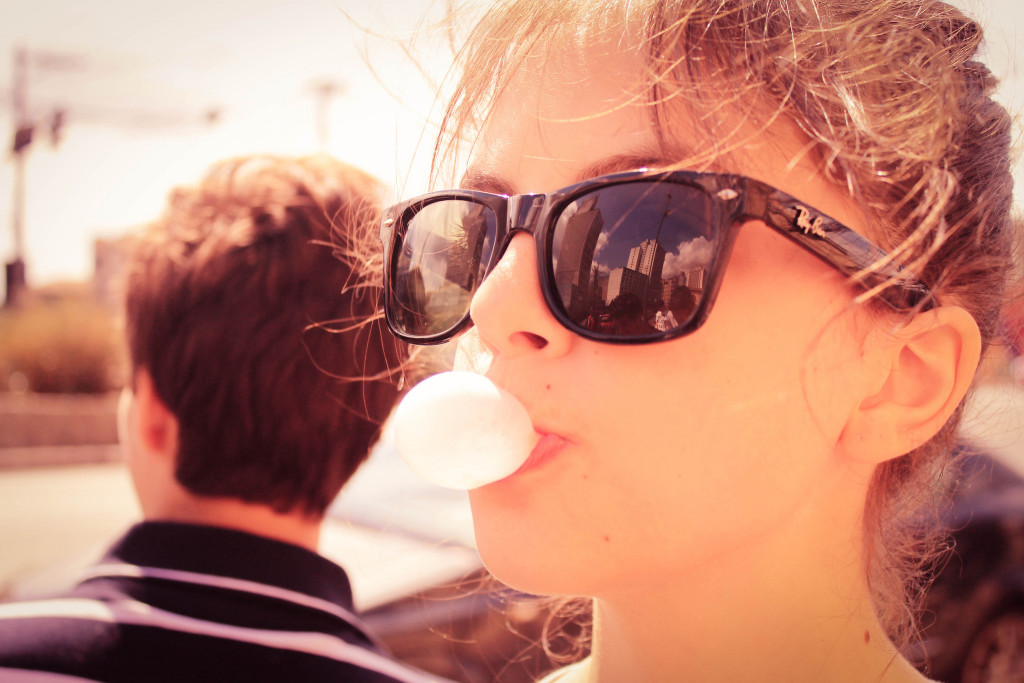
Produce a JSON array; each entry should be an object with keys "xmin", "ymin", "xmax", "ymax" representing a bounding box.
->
[{"xmin": 0, "ymin": 0, "xmax": 1024, "ymax": 287}]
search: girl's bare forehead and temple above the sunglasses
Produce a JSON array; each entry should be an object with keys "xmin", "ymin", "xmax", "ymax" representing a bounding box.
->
[{"xmin": 469, "ymin": 41, "xmax": 864, "ymax": 237}]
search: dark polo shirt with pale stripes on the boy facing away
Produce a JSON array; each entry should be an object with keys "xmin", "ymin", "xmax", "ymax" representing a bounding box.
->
[{"xmin": 0, "ymin": 522, "xmax": 452, "ymax": 683}]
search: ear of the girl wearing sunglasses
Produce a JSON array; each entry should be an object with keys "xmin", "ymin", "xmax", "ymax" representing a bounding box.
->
[{"xmin": 841, "ymin": 306, "xmax": 981, "ymax": 463}]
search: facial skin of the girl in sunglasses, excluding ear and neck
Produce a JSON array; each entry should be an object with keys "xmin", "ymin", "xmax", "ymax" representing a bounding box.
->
[{"xmin": 457, "ymin": 37, "xmax": 864, "ymax": 596}]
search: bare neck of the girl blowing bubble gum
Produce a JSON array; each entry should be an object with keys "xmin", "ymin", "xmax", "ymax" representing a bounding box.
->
[{"xmin": 566, "ymin": 464, "xmax": 926, "ymax": 683}]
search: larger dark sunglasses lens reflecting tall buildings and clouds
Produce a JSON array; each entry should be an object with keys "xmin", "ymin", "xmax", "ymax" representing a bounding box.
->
[{"xmin": 549, "ymin": 182, "xmax": 720, "ymax": 339}]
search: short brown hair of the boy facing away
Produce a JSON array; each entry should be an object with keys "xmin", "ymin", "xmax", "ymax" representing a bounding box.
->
[{"xmin": 126, "ymin": 157, "xmax": 403, "ymax": 517}]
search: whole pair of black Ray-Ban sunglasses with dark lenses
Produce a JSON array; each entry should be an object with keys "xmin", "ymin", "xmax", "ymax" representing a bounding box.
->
[{"xmin": 380, "ymin": 170, "xmax": 932, "ymax": 344}]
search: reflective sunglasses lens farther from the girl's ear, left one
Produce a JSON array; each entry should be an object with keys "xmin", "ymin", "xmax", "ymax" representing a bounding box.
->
[{"xmin": 389, "ymin": 199, "xmax": 497, "ymax": 337}]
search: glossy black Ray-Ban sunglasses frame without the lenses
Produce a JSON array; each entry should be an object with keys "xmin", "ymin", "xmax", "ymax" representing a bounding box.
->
[{"xmin": 380, "ymin": 169, "xmax": 935, "ymax": 345}]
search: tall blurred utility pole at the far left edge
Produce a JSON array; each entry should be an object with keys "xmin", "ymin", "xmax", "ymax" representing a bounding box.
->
[{"xmin": 5, "ymin": 46, "xmax": 33, "ymax": 306}]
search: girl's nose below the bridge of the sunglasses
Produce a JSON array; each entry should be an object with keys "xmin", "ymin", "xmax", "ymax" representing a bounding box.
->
[{"xmin": 470, "ymin": 232, "xmax": 573, "ymax": 355}]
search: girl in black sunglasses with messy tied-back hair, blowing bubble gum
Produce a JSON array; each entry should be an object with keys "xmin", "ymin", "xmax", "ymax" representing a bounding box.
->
[{"xmin": 382, "ymin": 0, "xmax": 1016, "ymax": 683}]
